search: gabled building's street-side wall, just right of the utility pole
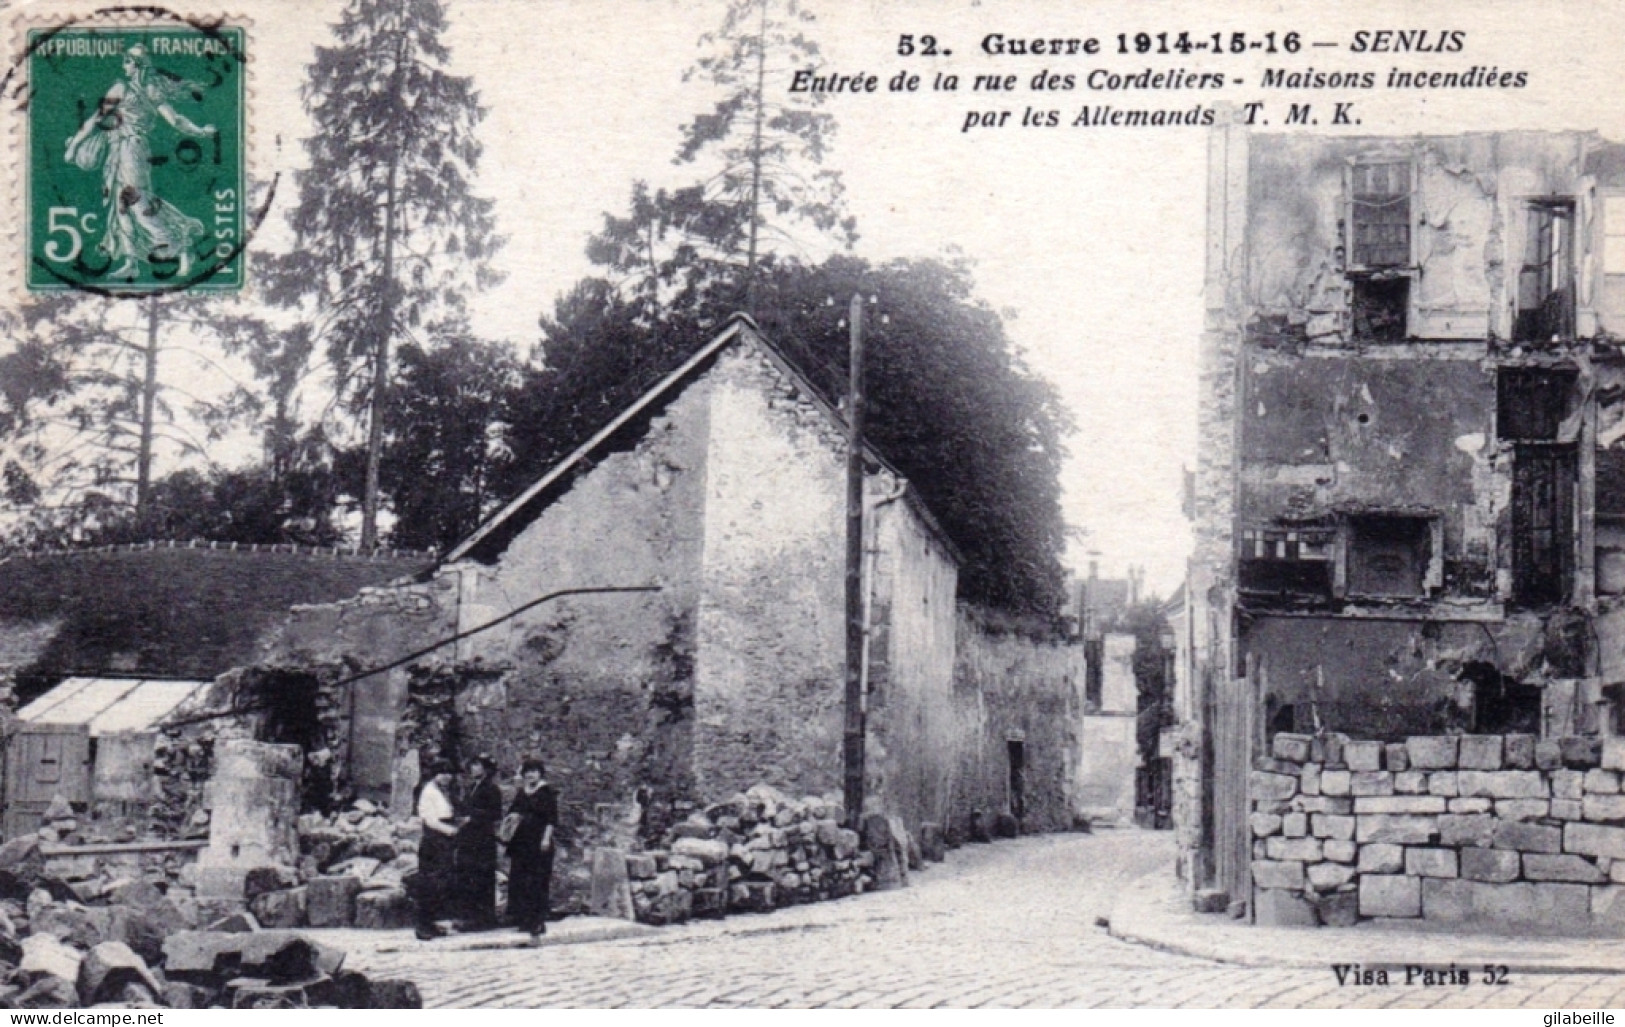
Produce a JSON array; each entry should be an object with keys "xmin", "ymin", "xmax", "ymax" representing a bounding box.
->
[{"xmin": 866, "ymin": 499, "xmax": 959, "ymax": 837}]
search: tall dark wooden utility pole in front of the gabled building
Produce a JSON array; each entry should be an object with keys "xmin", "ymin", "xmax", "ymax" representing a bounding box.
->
[{"xmin": 845, "ymin": 294, "xmax": 868, "ymax": 830}]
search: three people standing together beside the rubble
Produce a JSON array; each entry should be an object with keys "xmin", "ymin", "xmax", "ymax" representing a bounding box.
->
[{"xmin": 413, "ymin": 756, "xmax": 559, "ymax": 941}]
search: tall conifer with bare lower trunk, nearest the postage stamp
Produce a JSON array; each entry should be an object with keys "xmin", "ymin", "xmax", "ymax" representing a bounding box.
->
[{"xmin": 271, "ymin": 0, "xmax": 501, "ymax": 548}]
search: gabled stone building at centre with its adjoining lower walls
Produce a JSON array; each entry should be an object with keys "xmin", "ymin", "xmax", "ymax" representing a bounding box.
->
[{"xmin": 256, "ymin": 317, "xmax": 1082, "ymax": 892}]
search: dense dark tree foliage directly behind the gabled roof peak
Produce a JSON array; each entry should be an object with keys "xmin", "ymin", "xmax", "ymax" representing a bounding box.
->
[{"xmin": 505, "ymin": 257, "xmax": 1071, "ymax": 614}]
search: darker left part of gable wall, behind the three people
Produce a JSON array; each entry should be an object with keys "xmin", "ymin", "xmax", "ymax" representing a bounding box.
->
[{"xmin": 458, "ymin": 368, "xmax": 710, "ymax": 868}]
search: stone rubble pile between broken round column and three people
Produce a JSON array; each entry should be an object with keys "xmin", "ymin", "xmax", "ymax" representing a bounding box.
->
[{"xmin": 244, "ymin": 800, "xmax": 423, "ymax": 928}]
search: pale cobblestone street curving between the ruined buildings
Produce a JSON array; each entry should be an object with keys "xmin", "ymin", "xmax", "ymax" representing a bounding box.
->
[{"xmin": 329, "ymin": 830, "xmax": 1625, "ymax": 1009}]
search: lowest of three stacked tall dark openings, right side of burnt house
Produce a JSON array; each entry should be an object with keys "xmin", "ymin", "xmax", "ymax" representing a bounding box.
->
[{"xmin": 1513, "ymin": 444, "xmax": 1575, "ymax": 606}]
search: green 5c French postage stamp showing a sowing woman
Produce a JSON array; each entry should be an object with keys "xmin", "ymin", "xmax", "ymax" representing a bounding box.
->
[{"xmin": 26, "ymin": 21, "xmax": 245, "ymax": 293}]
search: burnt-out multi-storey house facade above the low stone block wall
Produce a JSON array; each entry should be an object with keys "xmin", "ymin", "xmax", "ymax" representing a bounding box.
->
[{"xmin": 1177, "ymin": 125, "xmax": 1625, "ymax": 916}]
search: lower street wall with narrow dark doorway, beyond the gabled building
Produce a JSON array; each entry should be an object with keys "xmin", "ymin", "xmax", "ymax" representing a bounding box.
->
[{"xmin": 947, "ymin": 606, "xmax": 1079, "ymax": 837}]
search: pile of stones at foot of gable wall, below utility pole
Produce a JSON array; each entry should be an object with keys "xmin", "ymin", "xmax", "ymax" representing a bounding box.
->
[{"xmin": 618, "ymin": 785, "xmax": 874, "ymax": 923}]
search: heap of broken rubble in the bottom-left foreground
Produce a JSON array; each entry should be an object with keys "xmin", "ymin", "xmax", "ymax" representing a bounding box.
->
[{"xmin": 0, "ymin": 835, "xmax": 421, "ymax": 1009}]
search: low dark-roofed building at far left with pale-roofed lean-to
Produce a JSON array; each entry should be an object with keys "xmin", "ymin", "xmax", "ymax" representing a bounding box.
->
[{"xmin": 0, "ymin": 541, "xmax": 432, "ymax": 837}]
